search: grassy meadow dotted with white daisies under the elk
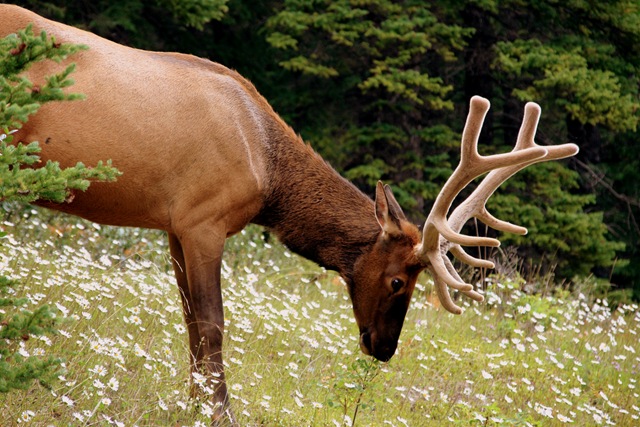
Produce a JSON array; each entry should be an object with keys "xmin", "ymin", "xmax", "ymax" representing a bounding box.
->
[{"xmin": 0, "ymin": 208, "xmax": 640, "ymax": 427}]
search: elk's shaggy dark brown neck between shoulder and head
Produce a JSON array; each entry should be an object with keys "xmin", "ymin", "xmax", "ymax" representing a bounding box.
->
[{"xmin": 253, "ymin": 125, "xmax": 380, "ymax": 278}]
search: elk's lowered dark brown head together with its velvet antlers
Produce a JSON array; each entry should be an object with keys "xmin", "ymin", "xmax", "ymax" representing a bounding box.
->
[{"xmin": 349, "ymin": 96, "xmax": 578, "ymax": 361}]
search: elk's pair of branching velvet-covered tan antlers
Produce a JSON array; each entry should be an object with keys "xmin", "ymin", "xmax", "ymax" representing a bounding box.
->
[{"xmin": 417, "ymin": 96, "xmax": 578, "ymax": 314}]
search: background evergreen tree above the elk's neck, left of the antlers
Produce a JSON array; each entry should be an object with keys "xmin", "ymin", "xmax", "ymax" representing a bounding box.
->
[{"xmin": 266, "ymin": 0, "xmax": 471, "ymax": 218}]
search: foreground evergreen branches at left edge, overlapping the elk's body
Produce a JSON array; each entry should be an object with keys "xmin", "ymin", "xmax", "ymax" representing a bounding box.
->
[{"xmin": 0, "ymin": 28, "xmax": 117, "ymax": 393}]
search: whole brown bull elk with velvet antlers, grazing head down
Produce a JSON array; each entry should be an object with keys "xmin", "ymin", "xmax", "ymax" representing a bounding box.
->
[{"xmin": 0, "ymin": 5, "xmax": 578, "ymax": 424}]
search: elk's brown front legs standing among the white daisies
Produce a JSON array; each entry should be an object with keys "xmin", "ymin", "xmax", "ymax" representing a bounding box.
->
[{"xmin": 170, "ymin": 227, "xmax": 235, "ymax": 424}]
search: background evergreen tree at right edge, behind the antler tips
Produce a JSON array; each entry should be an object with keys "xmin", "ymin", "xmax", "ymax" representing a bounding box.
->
[{"xmin": 461, "ymin": 0, "xmax": 640, "ymax": 286}]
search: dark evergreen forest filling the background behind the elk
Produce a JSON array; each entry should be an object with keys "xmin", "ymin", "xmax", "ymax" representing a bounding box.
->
[{"xmin": 8, "ymin": 0, "xmax": 640, "ymax": 298}]
